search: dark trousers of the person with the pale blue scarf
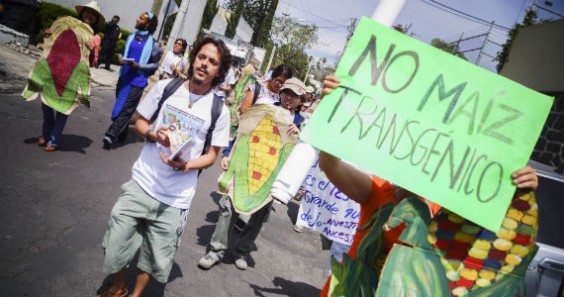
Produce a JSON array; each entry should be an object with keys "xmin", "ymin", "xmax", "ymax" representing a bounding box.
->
[{"xmin": 106, "ymin": 86, "xmax": 144, "ymax": 143}]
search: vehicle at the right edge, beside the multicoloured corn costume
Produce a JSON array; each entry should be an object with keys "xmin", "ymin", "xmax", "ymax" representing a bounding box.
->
[{"xmin": 525, "ymin": 161, "xmax": 564, "ymax": 297}]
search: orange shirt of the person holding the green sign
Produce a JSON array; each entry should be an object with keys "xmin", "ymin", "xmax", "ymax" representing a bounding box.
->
[{"xmin": 319, "ymin": 176, "xmax": 441, "ymax": 297}]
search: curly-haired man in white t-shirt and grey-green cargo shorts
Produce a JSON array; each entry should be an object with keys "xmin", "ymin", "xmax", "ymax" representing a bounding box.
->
[{"xmin": 98, "ymin": 37, "xmax": 232, "ymax": 297}]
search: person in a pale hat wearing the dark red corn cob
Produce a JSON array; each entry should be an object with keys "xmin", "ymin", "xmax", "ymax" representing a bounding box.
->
[{"xmin": 22, "ymin": 1, "xmax": 104, "ymax": 152}]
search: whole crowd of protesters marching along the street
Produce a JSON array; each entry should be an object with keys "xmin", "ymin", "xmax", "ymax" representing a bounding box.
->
[{"xmin": 23, "ymin": 1, "xmax": 538, "ymax": 297}]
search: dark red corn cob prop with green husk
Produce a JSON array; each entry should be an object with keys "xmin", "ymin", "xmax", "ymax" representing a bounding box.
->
[{"xmin": 22, "ymin": 17, "xmax": 93, "ymax": 115}]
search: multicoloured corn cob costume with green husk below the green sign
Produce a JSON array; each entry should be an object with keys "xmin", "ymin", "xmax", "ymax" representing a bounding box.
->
[{"xmin": 329, "ymin": 192, "xmax": 538, "ymax": 297}]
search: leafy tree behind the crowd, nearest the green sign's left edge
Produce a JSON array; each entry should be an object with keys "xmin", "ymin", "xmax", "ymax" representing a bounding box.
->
[{"xmin": 271, "ymin": 17, "xmax": 318, "ymax": 79}]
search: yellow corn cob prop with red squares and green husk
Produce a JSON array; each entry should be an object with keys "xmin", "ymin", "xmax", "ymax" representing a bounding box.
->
[{"xmin": 219, "ymin": 105, "xmax": 297, "ymax": 215}]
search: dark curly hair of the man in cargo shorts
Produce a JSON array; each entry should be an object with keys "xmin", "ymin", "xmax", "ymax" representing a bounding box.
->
[{"xmin": 188, "ymin": 36, "xmax": 232, "ymax": 88}]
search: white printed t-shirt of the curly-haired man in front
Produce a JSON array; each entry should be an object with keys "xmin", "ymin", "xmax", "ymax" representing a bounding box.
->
[{"xmin": 132, "ymin": 79, "xmax": 230, "ymax": 209}]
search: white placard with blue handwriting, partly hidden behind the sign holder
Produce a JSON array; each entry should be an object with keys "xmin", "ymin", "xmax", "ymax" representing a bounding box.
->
[{"xmin": 296, "ymin": 158, "xmax": 360, "ymax": 245}]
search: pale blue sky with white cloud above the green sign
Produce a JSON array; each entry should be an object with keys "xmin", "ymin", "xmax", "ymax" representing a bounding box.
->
[{"xmin": 276, "ymin": 0, "xmax": 534, "ymax": 71}]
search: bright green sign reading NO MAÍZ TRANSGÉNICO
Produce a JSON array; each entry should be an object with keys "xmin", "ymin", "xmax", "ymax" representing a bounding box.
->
[{"xmin": 300, "ymin": 18, "xmax": 553, "ymax": 231}]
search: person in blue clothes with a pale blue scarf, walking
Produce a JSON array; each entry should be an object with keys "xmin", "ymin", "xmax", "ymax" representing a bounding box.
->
[{"xmin": 103, "ymin": 12, "xmax": 161, "ymax": 150}]
